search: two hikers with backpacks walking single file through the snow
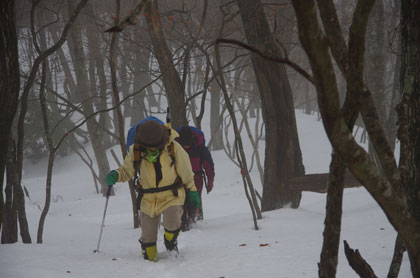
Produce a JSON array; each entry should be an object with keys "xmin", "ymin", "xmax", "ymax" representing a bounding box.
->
[{"xmin": 106, "ymin": 116, "xmax": 214, "ymax": 261}]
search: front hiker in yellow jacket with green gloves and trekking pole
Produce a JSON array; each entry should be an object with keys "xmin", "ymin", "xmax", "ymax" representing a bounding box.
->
[{"xmin": 106, "ymin": 120, "xmax": 200, "ymax": 261}]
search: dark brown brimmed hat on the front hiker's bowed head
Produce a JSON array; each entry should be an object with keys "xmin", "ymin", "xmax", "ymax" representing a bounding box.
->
[{"xmin": 134, "ymin": 120, "xmax": 169, "ymax": 149}]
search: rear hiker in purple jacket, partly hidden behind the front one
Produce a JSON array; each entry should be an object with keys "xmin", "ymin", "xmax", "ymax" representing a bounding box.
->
[{"xmin": 176, "ymin": 126, "xmax": 214, "ymax": 231}]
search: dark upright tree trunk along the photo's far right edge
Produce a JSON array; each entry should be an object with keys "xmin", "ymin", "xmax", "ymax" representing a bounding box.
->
[{"xmin": 399, "ymin": 0, "xmax": 420, "ymax": 277}]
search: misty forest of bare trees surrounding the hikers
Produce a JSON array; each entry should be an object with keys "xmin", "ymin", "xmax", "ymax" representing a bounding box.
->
[{"xmin": 0, "ymin": 0, "xmax": 420, "ymax": 277}]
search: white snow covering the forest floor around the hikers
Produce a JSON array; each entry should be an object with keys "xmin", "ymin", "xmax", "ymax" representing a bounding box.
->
[{"xmin": 0, "ymin": 111, "xmax": 411, "ymax": 278}]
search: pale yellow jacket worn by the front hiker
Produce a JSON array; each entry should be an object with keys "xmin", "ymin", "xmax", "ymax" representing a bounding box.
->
[{"xmin": 117, "ymin": 126, "xmax": 197, "ymax": 217}]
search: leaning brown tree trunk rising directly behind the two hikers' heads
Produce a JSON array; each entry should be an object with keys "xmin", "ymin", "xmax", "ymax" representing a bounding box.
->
[{"xmin": 144, "ymin": 1, "xmax": 188, "ymax": 127}]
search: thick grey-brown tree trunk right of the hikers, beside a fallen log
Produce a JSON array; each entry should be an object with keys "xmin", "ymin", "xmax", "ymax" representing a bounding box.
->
[{"xmin": 237, "ymin": 0, "xmax": 305, "ymax": 211}]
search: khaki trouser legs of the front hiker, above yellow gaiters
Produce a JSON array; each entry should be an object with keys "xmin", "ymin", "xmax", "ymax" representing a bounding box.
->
[{"xmin": 140, "ymin": 205, "xmax": 183, "ymax": 243}]
